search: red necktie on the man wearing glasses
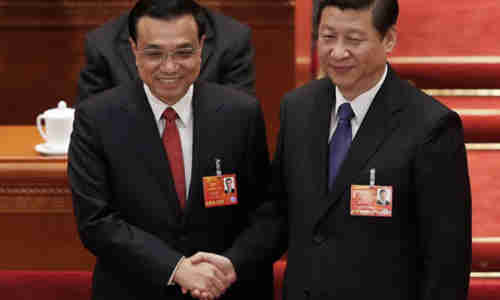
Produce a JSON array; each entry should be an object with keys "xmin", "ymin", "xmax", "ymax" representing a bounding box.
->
[{"xmin": 163, "ymin": 107, "xmax": 186, "ymax": 210}]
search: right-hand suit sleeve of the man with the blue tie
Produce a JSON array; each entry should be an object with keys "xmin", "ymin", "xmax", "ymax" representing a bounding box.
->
[{"xmin": 414, "ymin": 113, "xmax": 471, "ymax": 300}]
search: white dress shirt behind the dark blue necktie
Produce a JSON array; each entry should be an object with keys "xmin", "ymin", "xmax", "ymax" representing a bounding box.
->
[{"xmin": 328, "ymin": 65, "xmax": 387, "ymax": 142}]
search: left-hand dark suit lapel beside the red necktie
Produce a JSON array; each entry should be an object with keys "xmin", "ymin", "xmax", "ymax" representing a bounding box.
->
[{"xmin": 118, "ymin": 81, "xmax": 180, "ymax": 217}]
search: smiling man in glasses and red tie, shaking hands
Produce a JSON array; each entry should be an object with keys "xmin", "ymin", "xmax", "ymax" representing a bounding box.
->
[{"xmin": 68, "ymin": 0, "xmax": 272, "ymax": 299}]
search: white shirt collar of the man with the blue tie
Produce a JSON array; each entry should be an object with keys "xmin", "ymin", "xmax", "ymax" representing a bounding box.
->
[{"xmin": 334, "ymin": 65, "xmax": 388, "ymax": 123}]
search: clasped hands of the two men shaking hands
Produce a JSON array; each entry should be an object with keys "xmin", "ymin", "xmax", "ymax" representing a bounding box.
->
[{"xmin": 173, "ymin": 252, "xmax": 236, "ymax": 300}]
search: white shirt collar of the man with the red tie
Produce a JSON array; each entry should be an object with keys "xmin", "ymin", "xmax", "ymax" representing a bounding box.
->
[{"xmin": 144, "ymin": 83, "xmax": 193, "ymax": 127}]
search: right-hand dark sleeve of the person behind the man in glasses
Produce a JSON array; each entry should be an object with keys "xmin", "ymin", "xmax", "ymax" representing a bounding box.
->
[{"xmin": 219, "ymin": 28, "xmax": 255, "ymax": 95}]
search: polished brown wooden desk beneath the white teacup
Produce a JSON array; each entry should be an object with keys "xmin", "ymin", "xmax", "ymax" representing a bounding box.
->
[{"xmin": 0, "ymin": 126, "xmax": 95, "ymax": 270}]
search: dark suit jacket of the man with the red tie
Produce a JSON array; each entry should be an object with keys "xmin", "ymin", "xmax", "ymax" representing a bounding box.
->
[{"xmin": 68, "ymin": 81, "xmax": 272, "ymax": 299}]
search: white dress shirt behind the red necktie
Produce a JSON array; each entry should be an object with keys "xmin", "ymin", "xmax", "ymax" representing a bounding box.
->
[{"xmin": 144, "ymin": 84, "xmax": 193, "ymax": 201}]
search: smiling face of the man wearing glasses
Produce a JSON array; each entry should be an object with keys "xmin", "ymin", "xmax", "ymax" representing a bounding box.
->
[{"xmin": 130, "ymin": 15, "xmax": 204, "ymax": 105}]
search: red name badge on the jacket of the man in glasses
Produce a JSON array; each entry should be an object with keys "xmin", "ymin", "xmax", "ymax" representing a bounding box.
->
[{"xmin": 203, "ymin": 174, "xmax": 238, "ymax": 208}]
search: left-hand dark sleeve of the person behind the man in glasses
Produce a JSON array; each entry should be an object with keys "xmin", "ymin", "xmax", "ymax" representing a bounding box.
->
[{"xmin": 76, "ymin": 35, "xmax": 113, "ymax": 104}]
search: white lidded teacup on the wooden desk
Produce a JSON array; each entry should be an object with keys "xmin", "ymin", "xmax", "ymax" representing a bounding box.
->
[{"xmin": 36, "ymin": 101, "xmax": 75, "ymax": 151}]
